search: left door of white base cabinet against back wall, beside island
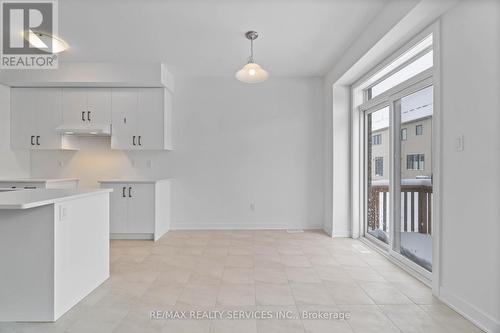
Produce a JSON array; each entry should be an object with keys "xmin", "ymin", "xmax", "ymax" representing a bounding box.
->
[{"xmin": 101, "ymin": 183, "xmax": 129, "ymax": 234}]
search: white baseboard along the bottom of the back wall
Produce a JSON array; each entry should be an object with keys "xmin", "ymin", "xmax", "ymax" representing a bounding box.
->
[{"xmin": 170, "ymin": 223, "xmax": 323, "ymax": 230}]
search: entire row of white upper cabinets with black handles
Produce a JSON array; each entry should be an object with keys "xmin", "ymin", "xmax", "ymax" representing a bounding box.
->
[{"xmin": 11, "ymin": 88, "xmax": 172, "ymax": 150}]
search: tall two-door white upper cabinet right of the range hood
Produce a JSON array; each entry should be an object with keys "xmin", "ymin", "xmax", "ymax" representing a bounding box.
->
[{"xmin": 111, "ymin": 88, "xmax": 172, "ymax": 150}]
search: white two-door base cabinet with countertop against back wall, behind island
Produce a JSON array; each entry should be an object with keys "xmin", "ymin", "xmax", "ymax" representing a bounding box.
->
[{"xmin": 100, "ymin": 179, "xmax": 170, "ymax": 241}]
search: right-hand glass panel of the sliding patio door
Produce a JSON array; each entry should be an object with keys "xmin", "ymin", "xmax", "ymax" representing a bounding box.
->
[{"xmin": 393, "ymin": 86, "xmax": 433, "ymax": 271}]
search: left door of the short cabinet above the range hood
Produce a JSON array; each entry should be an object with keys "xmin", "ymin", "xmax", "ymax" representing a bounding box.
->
[{"xmin": 62, "ymin": 88, "xmax": 88, "ymax": 126}]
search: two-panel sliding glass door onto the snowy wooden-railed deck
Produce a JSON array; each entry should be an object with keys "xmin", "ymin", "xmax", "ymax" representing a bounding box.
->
[{"xmin": 364, "ymin": 81, "xmax": 433, "ymax": 272}]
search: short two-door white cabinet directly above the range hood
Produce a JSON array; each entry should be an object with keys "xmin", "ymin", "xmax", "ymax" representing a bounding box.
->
[{"xmin": 62, "ymin": 88, "xmax": 111, "ymax": 127}]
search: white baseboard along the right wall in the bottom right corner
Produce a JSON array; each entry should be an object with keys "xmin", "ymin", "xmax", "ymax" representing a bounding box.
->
[{"xmin": 439, "ymin": 286, "xmax": 500, "ymax": 333}]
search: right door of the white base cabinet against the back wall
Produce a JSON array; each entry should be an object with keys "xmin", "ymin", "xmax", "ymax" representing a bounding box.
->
[{"xmin": 127, "ymin": 184, "xmax": 155, "ymax": 234}]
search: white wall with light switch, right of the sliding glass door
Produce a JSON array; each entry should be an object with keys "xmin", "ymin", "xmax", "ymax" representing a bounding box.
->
[{"xmin": 441, "ymin": 0, "xmax": 500, "ymax": 332}]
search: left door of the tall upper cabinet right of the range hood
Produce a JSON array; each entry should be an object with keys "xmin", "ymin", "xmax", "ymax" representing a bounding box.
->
[{"xmin": 111, "ymin": 88, "xmax": 137, "ymax": 150}]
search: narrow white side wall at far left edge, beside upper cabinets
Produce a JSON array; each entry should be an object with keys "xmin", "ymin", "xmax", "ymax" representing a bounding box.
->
[{"xmin": 0, "ymin": 85, "xmax": 30, "ymax": 178}]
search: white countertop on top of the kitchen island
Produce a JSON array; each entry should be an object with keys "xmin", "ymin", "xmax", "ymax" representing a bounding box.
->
[{"xmin": 0, "ymin": 188, "xmax": 113, "ymax": 209}]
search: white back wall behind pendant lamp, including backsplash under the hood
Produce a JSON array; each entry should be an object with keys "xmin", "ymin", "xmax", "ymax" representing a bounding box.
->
[{"xmin": 32, "ymin": 77, "xmax": 323, "ymax": 228}]
